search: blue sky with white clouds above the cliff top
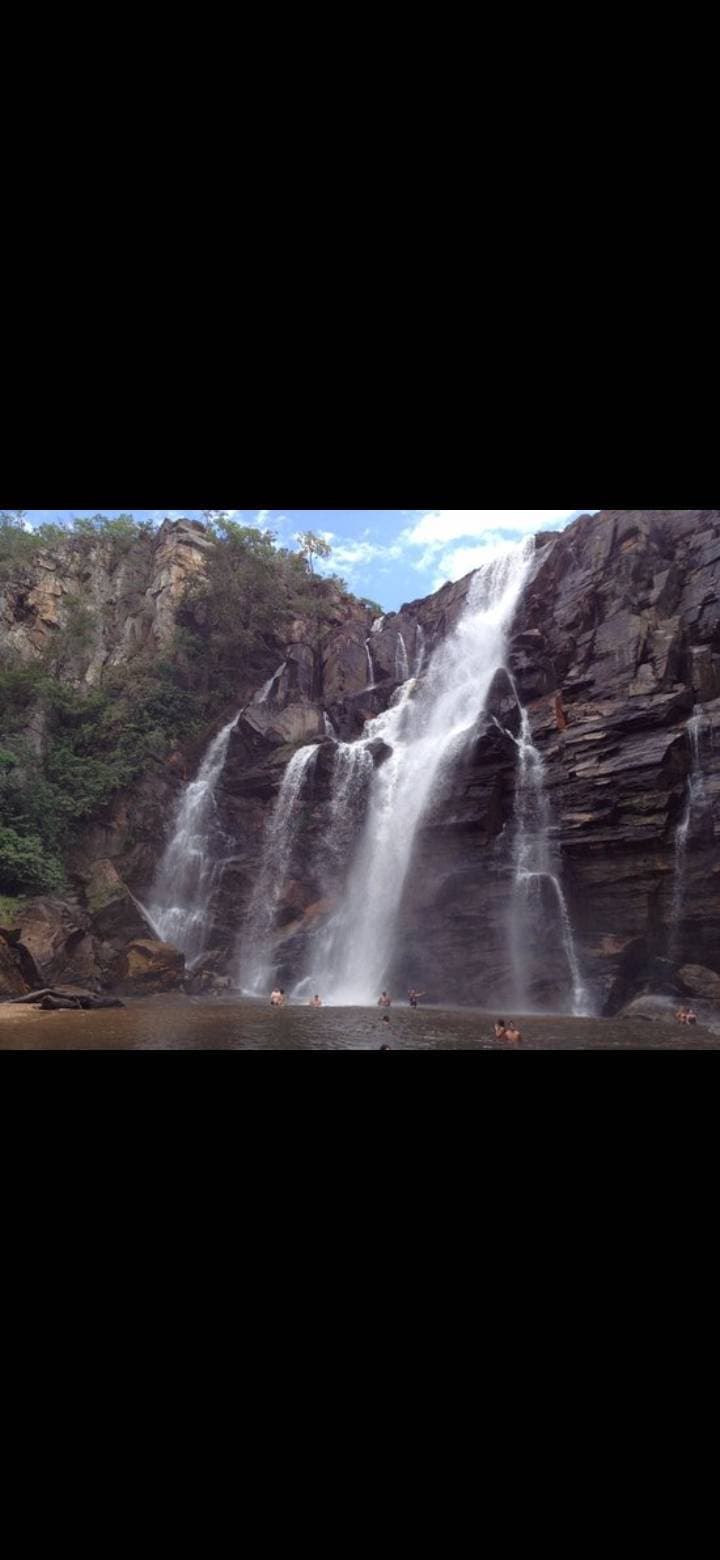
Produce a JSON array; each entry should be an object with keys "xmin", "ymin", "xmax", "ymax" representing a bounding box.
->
[{"xmin": 26, "ymin": 509, "xmax": 594, "ymax": 612}]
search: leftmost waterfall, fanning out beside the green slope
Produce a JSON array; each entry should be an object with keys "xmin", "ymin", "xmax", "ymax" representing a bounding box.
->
[{"xmin": 146, "ymin": 714, "xmax": 238, "ymax": 964}]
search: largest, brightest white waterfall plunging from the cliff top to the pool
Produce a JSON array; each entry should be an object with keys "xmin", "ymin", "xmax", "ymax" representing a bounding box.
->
[{"xmin": 297, "ymin": 540, "xmax": 535, "ymax": 1003}]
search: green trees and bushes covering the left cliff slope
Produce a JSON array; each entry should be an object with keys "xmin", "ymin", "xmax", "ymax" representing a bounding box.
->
[{"xmin": 0, "ymin": 512, "xmax": 382, "ymax": 903}]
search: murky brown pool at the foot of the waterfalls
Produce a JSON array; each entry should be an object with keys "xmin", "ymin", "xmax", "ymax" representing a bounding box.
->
[{"xmin": 0, "ymin": 997, "xmax": 720, "ymax": 1051}]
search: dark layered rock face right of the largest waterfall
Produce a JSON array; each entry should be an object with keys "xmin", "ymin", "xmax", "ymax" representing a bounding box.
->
[{"xmin": 388, "ymin": 512, "xmax": 720, "ymax": 1011}]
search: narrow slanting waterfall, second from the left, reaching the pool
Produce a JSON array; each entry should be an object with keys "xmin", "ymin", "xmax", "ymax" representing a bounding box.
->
[{"xmin": 237, "ymin": 743, "xmax": 318, "ymax": 994}]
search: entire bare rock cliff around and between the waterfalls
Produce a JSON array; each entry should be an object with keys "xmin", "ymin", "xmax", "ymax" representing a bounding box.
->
[{"xmin": 0, "ymin": 510, "xmax": 720, "ymax": 1011}]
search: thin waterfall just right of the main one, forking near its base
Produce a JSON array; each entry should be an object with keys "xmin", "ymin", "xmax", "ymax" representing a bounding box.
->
[{"xmin": 508, "ymin": 705, "xmax": 589, "ymax": 1017}]
